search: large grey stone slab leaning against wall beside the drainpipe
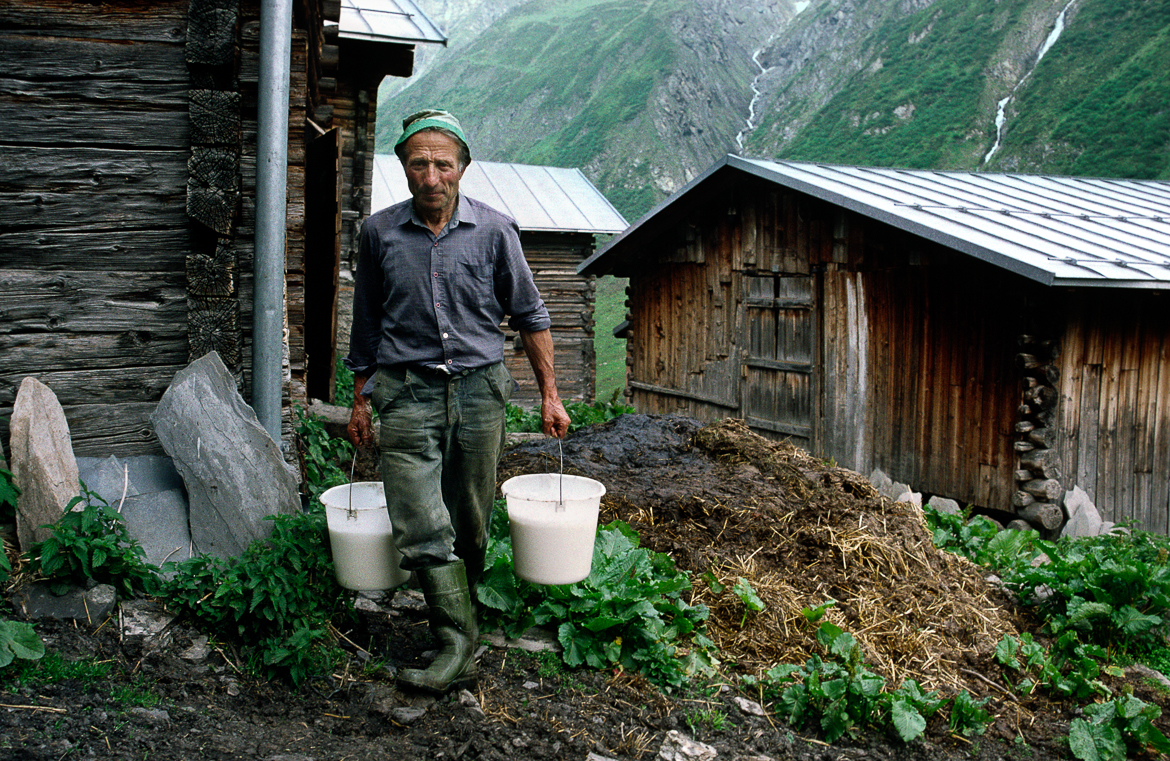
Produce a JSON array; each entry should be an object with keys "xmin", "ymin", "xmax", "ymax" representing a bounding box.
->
[{"xmin": 151, "ymin": 351, "xmax": 301, "ymax": 557}]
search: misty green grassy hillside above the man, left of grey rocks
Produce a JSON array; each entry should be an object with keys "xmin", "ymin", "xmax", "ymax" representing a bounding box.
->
[{"xmin": 377, "ymin": 0, "xmax": 682, "ymax": 214}]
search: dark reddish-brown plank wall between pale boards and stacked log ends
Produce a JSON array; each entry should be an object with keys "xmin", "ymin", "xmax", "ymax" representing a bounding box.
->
[{"xmin": 851, "ymin": 245, "xmax": 1021, "ymax": 510}]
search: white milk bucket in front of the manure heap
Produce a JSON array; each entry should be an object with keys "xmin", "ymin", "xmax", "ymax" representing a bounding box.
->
[{"xmin": 500, "ymin": 473, "xmax": 605, "ymax": 584}]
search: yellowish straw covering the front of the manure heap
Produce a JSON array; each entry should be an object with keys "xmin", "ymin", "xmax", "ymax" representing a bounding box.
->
[{"xmin": 635, "ymin": 420, "xmax": 1018, "ymax": 694}]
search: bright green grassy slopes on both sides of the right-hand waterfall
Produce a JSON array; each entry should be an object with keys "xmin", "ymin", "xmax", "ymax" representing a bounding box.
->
[{"xmin": 748, "ymin": 0, "xmax": 1170, "ymax": 178}]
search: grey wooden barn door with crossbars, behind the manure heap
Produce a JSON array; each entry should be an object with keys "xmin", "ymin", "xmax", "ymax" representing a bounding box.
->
[{"xmin": 743, "ymin": 274, "xmax": 817, "ymax": 450}]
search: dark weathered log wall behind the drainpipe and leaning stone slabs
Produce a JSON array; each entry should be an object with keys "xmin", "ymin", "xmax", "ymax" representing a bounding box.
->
[{"xmin": 0, "ymin": 0, "xmax": 337, "ymax": 457}]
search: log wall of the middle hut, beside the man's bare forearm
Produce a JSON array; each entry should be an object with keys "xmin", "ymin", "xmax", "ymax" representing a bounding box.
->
[{"xmin": 504, "ymin": 232, "xmax": 597, "ymax": 407}]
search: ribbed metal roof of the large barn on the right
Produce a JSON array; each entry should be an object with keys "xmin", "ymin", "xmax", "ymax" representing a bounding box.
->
[{"xmin": 578, "ymin": 156, "xmax": 1170, "ymax": 289}]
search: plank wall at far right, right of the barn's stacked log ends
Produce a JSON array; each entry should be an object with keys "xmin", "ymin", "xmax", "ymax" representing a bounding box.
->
[{"xmin": 1055, "ymin": 289, "xmax": 1170, "ymax": 534}]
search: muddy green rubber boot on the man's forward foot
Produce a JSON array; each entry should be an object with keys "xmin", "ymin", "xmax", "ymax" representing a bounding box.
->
[{"xmin": 398, "ymin": 560, "xmax": 480, "ymax": 695}]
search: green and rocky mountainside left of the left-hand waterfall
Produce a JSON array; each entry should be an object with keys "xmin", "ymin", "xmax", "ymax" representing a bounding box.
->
[{"xmin": 378, "ymin": 0, "xmax": 792, "ymax": 217}]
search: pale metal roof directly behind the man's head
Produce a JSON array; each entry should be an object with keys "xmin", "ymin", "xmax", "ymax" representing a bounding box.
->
[{"xmin": 371, "ymin": 153, "xmax": 628, "ymax": 234}]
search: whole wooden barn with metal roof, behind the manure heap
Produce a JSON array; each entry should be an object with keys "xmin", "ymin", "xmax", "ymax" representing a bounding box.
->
[{"xmin": 580, "ymin": 156, "xmax": 1170, "ymax": 533}]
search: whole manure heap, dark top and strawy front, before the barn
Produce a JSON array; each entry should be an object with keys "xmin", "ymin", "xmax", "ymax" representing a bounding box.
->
[{"xmin": 500, "ymin": 414, "xmax": 1018, "ymax": 695}]
